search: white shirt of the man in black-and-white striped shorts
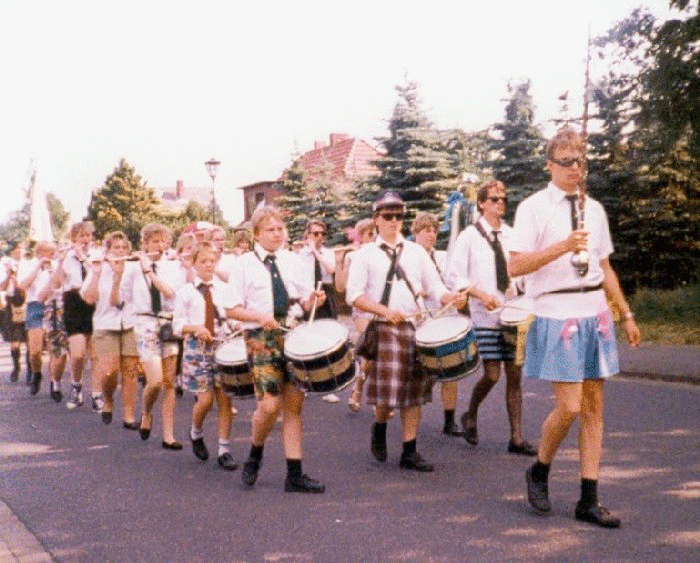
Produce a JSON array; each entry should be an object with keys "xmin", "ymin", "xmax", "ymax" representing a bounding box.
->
[{"xmin": 445, "ymin": 216, "xmax": 513, "ymax": 328}]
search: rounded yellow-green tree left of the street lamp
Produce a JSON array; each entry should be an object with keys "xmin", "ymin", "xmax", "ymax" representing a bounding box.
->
[{"xmin": 86, "ymin": 158, "xmax": 160, "ymax": 247}]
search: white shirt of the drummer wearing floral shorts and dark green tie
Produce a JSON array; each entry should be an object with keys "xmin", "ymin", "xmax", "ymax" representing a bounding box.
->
[{"xmin": 229, "ymin": 243, "xmax": 314, "ymax": 329}]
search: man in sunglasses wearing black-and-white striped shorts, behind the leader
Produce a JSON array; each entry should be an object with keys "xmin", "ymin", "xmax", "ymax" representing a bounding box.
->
[{"xmin": 446, "ymin": 180, "xmax": 537, "ymax": 455}]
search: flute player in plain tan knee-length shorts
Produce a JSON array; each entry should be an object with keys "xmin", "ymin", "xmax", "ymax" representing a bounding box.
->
[{"xmin": 80, "ymin": 231, "xmax": 139, "ymax": 430}]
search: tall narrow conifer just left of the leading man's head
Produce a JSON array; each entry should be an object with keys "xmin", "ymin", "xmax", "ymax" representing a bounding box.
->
[{"xmin": 484, "ymin": 80, "xmax": 548, "ymax": 218}]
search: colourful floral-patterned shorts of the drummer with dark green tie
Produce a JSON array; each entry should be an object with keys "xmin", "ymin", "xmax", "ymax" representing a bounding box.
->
[{"xmin": 245, "ymin": 328, "xmax": 292, "ymax": 398}]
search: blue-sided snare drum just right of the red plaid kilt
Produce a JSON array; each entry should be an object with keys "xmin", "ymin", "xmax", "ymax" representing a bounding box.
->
[{"xmin": 416, "ymin": 315, "xmax": 480, "ymax": 382}]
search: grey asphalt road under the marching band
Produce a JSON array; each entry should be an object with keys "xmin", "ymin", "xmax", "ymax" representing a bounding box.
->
[{"xmin": 0, "ymin": 350, "xmax": 700, "ymax": 563}]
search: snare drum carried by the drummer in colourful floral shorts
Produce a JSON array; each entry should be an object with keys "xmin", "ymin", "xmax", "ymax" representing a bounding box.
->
[{"xmin": 284, "ymin": 319, "xmax": 355, "ymax": 393}]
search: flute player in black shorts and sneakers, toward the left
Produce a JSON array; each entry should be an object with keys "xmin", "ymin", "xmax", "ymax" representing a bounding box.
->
[{"xmin": 58, "ymin": 221, "xmax": 98, "ymax": 412}]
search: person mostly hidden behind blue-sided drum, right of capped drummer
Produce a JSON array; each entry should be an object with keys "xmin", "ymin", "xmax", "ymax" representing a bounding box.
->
[{"xmin": 411, "ymin": 211, "xmax": 464, "ymax": 436}]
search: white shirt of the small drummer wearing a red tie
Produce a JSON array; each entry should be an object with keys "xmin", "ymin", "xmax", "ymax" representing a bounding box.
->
[{"xmin": 173, "ymin": 277, "xmax": 233, "ymax": 336}]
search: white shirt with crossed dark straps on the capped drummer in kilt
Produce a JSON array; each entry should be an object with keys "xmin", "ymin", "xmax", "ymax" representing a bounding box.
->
[{"xmin": 345, "ymin": 236, "xmax": 448, "ymax": 320}]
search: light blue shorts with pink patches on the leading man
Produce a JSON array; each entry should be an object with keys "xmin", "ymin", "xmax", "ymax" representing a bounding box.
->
[{"xmin": 523, "ymin": 311, "xmax": 620, "ymax": 383}]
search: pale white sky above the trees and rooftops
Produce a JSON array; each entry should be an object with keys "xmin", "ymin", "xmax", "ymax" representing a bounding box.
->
[{"xmin": 0, "ymin": 0, "xmax": 680, "ymax": 229}]
